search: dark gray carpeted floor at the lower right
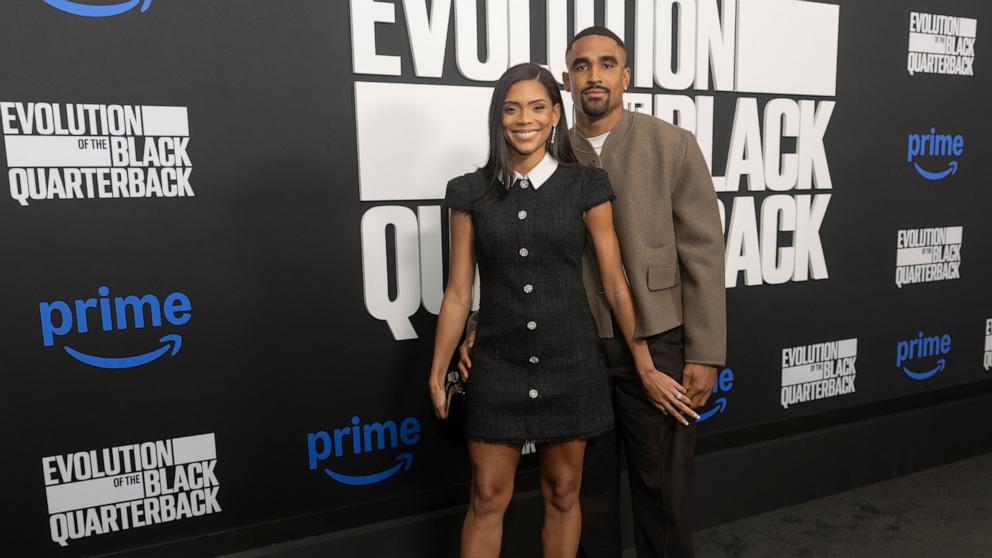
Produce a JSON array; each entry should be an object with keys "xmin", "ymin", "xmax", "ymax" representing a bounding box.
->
[{"xmin": 695, "ymin": 454, "xmax": 992, "ymax": 558}]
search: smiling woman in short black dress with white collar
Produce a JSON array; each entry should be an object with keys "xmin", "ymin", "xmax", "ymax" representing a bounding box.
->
[{"xmin": 429, "ymin": 64, "xmax": 695, "ymax": 558}]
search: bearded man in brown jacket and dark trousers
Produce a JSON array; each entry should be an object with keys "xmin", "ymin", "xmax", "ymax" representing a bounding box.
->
[{"xmin": 460, "ymin": 26, "xmax": 726, "ymax": 558}]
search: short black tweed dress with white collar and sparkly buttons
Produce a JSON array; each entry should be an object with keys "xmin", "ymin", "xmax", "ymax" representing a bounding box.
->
[{"xmin": 444, "ymin": 164, "xmax": 615, "ymax": 444}]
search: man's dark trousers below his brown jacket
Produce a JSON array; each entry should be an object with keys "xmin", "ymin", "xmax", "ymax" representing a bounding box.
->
[{"xmin": 579, "ymin": 327, "xmax": 696, "ymax": 558}]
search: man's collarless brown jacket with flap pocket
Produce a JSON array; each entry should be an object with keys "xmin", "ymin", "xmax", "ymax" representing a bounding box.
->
[{"xmin": 569, "ymin": 111, "xmax": 727, "ymax": 366}]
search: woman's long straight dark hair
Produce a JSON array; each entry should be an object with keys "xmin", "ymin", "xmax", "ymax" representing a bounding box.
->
[{"xmin": 482, "ymin": 62, "xmax": 576, "ymax": 197}]
